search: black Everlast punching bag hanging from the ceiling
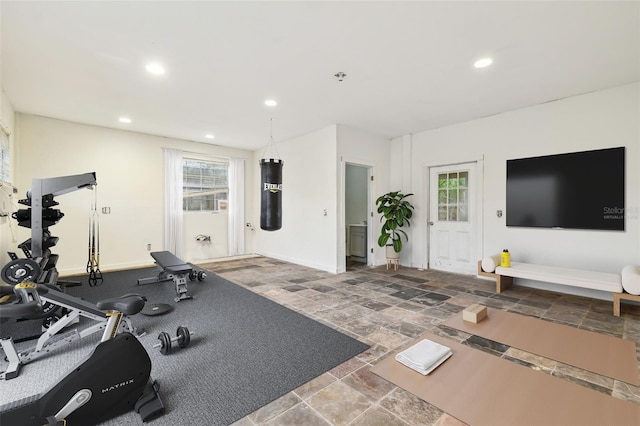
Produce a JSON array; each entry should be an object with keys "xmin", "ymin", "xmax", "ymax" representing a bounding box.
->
[{"xmin": 260, "ymin": 158, "xmax": 284, "ymax": 231}]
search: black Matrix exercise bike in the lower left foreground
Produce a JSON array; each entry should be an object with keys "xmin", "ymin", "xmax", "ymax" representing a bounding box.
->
[{"xmin": 0, "ymin": 282, "xmax": 164, "ymax": 426}]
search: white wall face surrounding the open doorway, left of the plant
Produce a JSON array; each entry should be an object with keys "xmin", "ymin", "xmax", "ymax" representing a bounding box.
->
[{"xmin": 336, "ymin": 125, "xmax": 391, "ymax": 272}]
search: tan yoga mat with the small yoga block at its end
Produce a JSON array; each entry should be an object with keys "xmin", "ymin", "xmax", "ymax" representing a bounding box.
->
[{"xmin": 443, "ymin": 308, "xmax": 640, "ymax": 386}]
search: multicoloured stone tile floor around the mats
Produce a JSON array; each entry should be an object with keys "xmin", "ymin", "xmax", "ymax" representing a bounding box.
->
[{"xmin": 200, "ymin": 257, "xmax": 640, "ymax": 426}]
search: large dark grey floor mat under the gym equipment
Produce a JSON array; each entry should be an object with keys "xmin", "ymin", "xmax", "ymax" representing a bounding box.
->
[{"xmin": 0, "ymin": 268, "xmax": 368, "ymax": 426}]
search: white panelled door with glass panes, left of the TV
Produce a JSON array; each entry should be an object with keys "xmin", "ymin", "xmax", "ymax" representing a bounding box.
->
[{"xmin": 428, "ymin": 163, "xmax": 477, "ymax": 274}]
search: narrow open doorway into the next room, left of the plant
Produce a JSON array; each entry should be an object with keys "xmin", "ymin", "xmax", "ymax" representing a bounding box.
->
[{"xmin": 344, "ymin": 163, "xmax": 371, "ymax": 269}]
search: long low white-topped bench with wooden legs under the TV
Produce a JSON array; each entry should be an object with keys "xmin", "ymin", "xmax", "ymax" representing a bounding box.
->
[{"xmin": 478, "ymin": 261, "xmax": 640, "ymax": 317}]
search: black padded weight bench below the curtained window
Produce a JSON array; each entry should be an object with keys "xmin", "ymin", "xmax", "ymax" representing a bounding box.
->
[{"xmin": 138, "ymin": 251, "xmax": 207, "ymax": 302}]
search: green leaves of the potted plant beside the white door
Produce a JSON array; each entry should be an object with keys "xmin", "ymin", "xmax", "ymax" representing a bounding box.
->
[{"xmin": 376, "ymin": 191, "xmax": 414, "ymax": 253}]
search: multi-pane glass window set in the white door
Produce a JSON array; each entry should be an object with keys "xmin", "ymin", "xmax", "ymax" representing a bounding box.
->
[{"xmin": 438, "ymin": 172, "xmax": 469, "ymax": 222}]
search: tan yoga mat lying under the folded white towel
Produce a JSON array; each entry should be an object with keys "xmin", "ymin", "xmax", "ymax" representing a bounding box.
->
[{"xmin": 371, "ymin": 333, "xmax": 640, "ymax": 426}]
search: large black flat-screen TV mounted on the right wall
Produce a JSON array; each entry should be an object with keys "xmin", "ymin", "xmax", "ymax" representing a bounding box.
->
[{"xmin": 506, "ymin": 147, "xmax": 625, "ymax": 231}]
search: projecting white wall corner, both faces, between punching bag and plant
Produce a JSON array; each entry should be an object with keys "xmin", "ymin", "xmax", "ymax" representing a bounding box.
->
[{"xmin": 252, "ymin": 125, "xmax": 389, "ymax": 273}]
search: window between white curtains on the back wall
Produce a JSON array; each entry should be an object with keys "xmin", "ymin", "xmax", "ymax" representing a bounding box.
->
[{"xmin": 182, "ymin": 158, "xmax": 229, "ymax": 212}]
